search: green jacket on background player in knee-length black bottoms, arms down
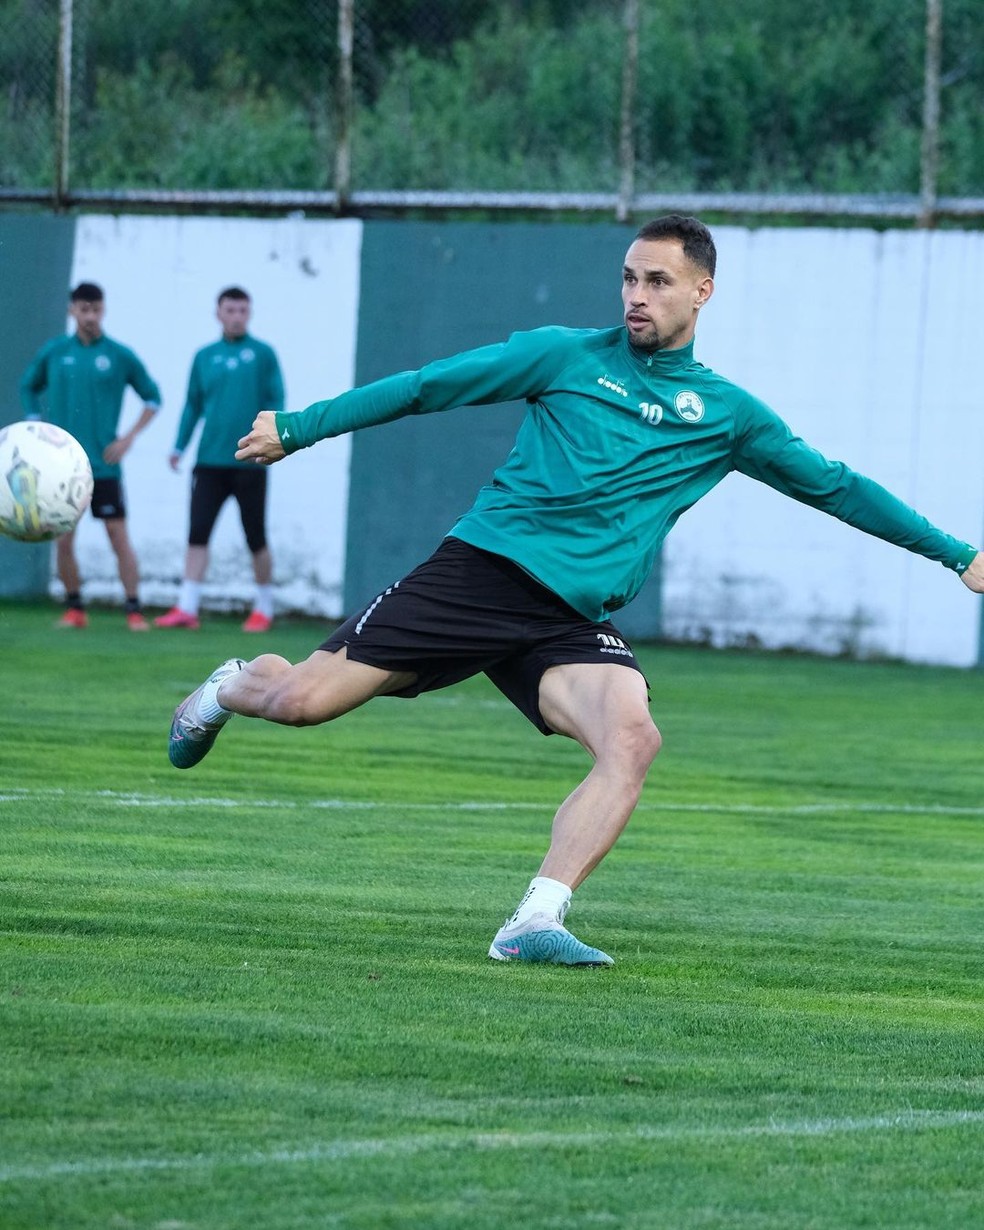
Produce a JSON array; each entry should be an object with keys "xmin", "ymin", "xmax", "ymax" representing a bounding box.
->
[{"xmin": 175, "ymin": 333, "xmax": 284, "ymax": 467}]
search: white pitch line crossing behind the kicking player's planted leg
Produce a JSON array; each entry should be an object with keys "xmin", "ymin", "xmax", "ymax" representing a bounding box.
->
[{"xmin": 0, "ymin": 787, "xmax": 984, "ymax": 817}]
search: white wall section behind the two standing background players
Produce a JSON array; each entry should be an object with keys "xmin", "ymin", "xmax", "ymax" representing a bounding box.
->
[{"xmin": 67, "ymin": 216, "xmax": 362, "ymax": 614}]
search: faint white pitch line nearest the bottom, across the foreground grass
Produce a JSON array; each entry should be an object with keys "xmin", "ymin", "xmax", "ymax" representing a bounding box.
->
[{"xmin": 0, "ymin": 1109, "xmax": 984, "ymax": 1183}]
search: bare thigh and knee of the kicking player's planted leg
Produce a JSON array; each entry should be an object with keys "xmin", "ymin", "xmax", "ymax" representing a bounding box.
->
[{"xmin": 540, "ymin": 662, "xmax": 659, "ymax": 760}]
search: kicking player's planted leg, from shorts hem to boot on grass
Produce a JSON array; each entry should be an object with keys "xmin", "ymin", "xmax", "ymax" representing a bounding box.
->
[{"xmin": 488, "ymin": 663, "xmax": 661, "ymax": 966}]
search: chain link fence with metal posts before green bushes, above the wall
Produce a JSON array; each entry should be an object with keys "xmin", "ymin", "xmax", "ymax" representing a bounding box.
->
[{"xmin": 0, "ymin": 0, "xmax": 984, "ymax": 223}]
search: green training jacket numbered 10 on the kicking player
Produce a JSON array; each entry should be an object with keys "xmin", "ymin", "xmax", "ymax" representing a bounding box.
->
[{"xmin": 277, "ymin": 327, "xmax": 977, "ymax": 620}]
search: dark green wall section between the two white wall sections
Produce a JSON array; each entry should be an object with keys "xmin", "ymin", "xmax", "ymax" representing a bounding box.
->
[{"xmin": 344, "ymin": 221, "xmax": 659, "ymax": 637}]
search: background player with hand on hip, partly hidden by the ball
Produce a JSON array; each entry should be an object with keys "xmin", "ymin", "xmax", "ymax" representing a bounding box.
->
[{"xmin": 21, "ymin": 282, "xmax": 161, "ymax": 632}]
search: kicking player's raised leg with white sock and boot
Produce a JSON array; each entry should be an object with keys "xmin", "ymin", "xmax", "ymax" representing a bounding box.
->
[{"xmin": 167, "ymin": 649, "xmax": 415, "ymax": 769}]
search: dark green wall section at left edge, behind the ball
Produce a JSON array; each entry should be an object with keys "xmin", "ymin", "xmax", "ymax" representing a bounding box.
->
[{"xmin": 0, "ymin": 214, "xmax": 75, "ymax": 598}]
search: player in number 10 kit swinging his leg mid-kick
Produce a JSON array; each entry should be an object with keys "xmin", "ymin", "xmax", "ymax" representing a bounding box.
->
[{"xmin": 169, "ymin": 214, "xmax": 984, "ymax": 966}]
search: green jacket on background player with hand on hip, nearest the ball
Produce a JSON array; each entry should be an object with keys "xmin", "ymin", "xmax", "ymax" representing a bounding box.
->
[{"xmin": 21, "ymin": 333, "xmax": 161, "ymax": 478}]
